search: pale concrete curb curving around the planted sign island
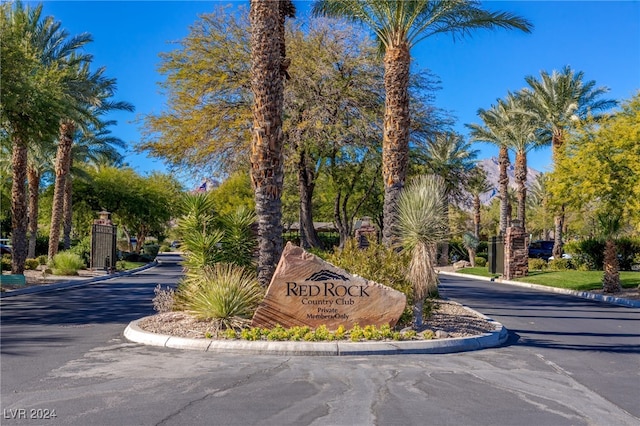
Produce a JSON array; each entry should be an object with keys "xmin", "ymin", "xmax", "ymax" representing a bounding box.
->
[{"xmin": 124, "ymin": 307, "xmax": 509, "ymax": 356}]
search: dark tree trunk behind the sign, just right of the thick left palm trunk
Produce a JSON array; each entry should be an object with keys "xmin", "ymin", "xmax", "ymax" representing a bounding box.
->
[{"xmin": 298, "ymin": 149, "xmax": 322, "ymax": 249}]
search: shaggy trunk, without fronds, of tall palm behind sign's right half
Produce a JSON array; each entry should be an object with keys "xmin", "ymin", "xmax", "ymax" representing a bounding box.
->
[{"xmin": 382, "ymin": 43, "xmax": 411, "ymax": 247}]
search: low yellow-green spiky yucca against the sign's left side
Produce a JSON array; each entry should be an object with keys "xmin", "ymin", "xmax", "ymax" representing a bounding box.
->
[{"xmin": 175, "ymin": 263, "xmax": 264, "ymax": 328}]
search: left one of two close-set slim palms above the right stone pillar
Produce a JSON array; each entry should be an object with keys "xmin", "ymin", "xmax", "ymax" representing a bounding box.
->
[{"xmin": 467, "ymin": 99, "xmax": 510, "ymax": 235}]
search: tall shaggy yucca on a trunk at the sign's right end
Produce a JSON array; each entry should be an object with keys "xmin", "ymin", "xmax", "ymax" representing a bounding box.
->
[{"xmin": 396, "ymin": 175, "xmax": 447, "ymax": 328}]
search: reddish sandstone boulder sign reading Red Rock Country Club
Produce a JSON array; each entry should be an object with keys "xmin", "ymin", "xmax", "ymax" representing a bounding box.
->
[{"xmin": 251, "ymin": 243, "xmax": 406, "ymax": 330}]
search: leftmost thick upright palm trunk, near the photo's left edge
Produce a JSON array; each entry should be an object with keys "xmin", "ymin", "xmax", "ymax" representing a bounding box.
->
[{"xmin": 11, "ymin": 136, "xmax": 27, "ymax": 274}]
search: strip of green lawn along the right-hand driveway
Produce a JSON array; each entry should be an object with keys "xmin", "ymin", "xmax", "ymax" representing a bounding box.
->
[{"xmin": 457, "ymin": 267, "xmax": 640, "ymax": 290}]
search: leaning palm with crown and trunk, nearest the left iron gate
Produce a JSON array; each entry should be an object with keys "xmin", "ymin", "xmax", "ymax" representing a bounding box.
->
[{"xmin": 48, "ymin": 62, "xmax": 134, "ymax": 259}]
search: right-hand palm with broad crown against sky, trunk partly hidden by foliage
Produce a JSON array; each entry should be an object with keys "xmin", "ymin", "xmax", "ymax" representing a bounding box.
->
[{"xmin": 523, "ymin": 65, "xmax": 617, "ymax": 259}]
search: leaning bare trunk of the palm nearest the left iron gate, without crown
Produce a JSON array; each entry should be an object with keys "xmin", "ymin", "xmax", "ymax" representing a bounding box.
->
[{"xmin": 48, "ymin": 122, "xmax": 75, "ymax": 260}]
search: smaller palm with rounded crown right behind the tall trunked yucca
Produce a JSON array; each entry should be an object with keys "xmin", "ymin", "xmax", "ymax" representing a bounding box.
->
[{"xmin": 422, "ymin": 132, "xmax": 478, "ymax": 265}]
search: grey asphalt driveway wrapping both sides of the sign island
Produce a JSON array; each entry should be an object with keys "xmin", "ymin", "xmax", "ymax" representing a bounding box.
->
[{"xmin": 0, "ymin": 257, "xmax": 640, "ymax": 426}]
